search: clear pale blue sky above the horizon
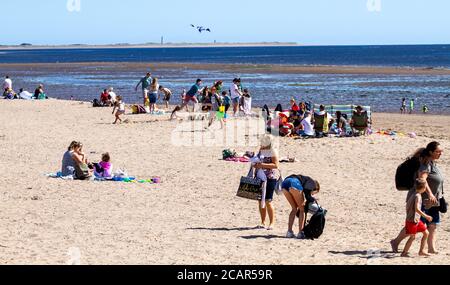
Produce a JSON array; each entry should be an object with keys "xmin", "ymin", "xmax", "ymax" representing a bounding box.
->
[{"xmin": 0, "ymin": 0, "xmax": 450, "ymax": 45}]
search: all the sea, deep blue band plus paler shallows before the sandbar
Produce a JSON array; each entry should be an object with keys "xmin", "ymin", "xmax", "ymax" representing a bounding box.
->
[{"xmin": 0, "ymin": 45, "xmax": 450, "ymax": 114}]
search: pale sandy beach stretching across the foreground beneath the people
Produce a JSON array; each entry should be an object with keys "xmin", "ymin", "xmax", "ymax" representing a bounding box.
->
[{"xmin": 0, "ymin": 99, "xmax": 450, "ymax": 265}]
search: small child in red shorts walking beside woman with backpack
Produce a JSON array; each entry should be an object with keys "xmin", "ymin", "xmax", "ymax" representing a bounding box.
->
[{"xmin": 401, "ymin": 179, "xmax": 433, "ymax": 257}]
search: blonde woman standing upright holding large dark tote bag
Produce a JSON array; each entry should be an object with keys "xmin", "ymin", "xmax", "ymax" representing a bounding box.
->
[{"xmin": 254, "ymin": 135, "xmax": 279, "ymax": 230}]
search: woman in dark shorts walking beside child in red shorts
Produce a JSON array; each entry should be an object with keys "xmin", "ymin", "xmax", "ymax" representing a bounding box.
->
[{"xmin": 391, "ymin": 142, "xmax": 445, "ymax": 254}]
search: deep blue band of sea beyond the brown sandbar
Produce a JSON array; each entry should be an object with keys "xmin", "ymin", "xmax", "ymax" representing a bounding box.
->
[{"xmin": 0, "ymin": 45, "xmax": 450, "ymax": 68}]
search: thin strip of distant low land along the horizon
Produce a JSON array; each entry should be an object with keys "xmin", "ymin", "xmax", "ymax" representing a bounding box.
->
[{"xmin": 0, "ymin": 42, "xmax": 302, "ymax": 50}]
